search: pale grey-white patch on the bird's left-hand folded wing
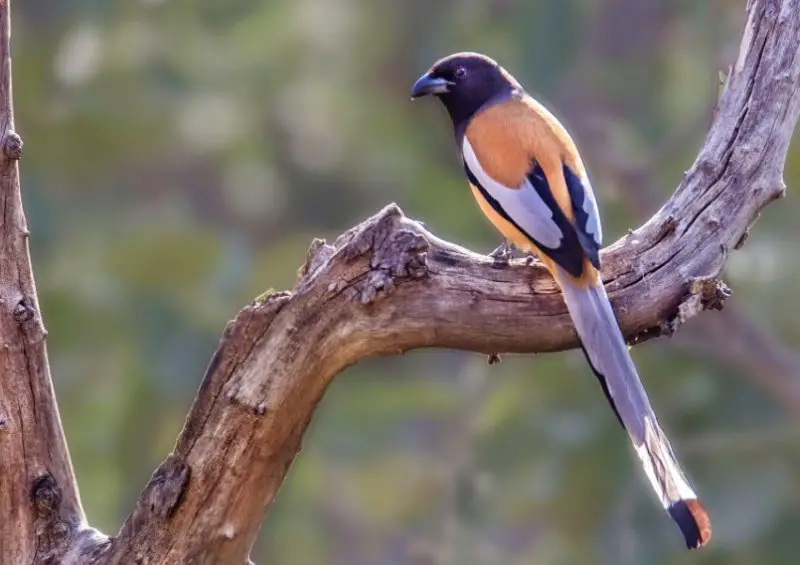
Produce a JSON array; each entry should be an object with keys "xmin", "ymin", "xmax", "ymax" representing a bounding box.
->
[{"xmin": 462, "ymin": 136, "xmax": 564, "ymax": 249}]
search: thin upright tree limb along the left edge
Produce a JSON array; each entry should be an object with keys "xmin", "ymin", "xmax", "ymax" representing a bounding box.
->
[{"xmin": 0, "ymin": 0, "xmax": 99, "ymax": 563}]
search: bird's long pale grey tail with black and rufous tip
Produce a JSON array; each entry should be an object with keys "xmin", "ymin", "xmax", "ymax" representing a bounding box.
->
[{"xmin": 556, "ymin": 270, "xmax": 711, "ymax": 549}]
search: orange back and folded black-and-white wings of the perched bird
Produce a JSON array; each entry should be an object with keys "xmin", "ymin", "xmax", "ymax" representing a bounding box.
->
[{"xmin": 461, "ymin": 95, "xmax": 602, "ymax": 277}]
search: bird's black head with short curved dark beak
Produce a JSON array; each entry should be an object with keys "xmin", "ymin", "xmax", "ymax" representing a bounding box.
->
[{"xmin": 411, "ymin": 53, "xmax": 520, "ymax": 130}]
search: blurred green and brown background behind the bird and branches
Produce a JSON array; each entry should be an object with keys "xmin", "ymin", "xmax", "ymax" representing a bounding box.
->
[{"xmin": 12, "ymin": 0, "xmax": 800, "ymax": 565}]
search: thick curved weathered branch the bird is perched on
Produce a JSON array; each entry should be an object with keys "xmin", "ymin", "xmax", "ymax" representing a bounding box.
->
[{"xmin": 95, "ymin": 0, "xmax": 800, "ymax": 563}]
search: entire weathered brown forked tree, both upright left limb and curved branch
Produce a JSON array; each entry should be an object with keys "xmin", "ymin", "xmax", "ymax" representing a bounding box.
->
[{"xmin": 0, "ymin": 0, "xmax": 800, "ymax": 564}]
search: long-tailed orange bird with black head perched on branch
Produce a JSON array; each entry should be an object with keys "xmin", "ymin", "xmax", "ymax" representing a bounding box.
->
[{"xmin": 411, "ymin": 52, "xmax": 711, "ymax": 549}]
